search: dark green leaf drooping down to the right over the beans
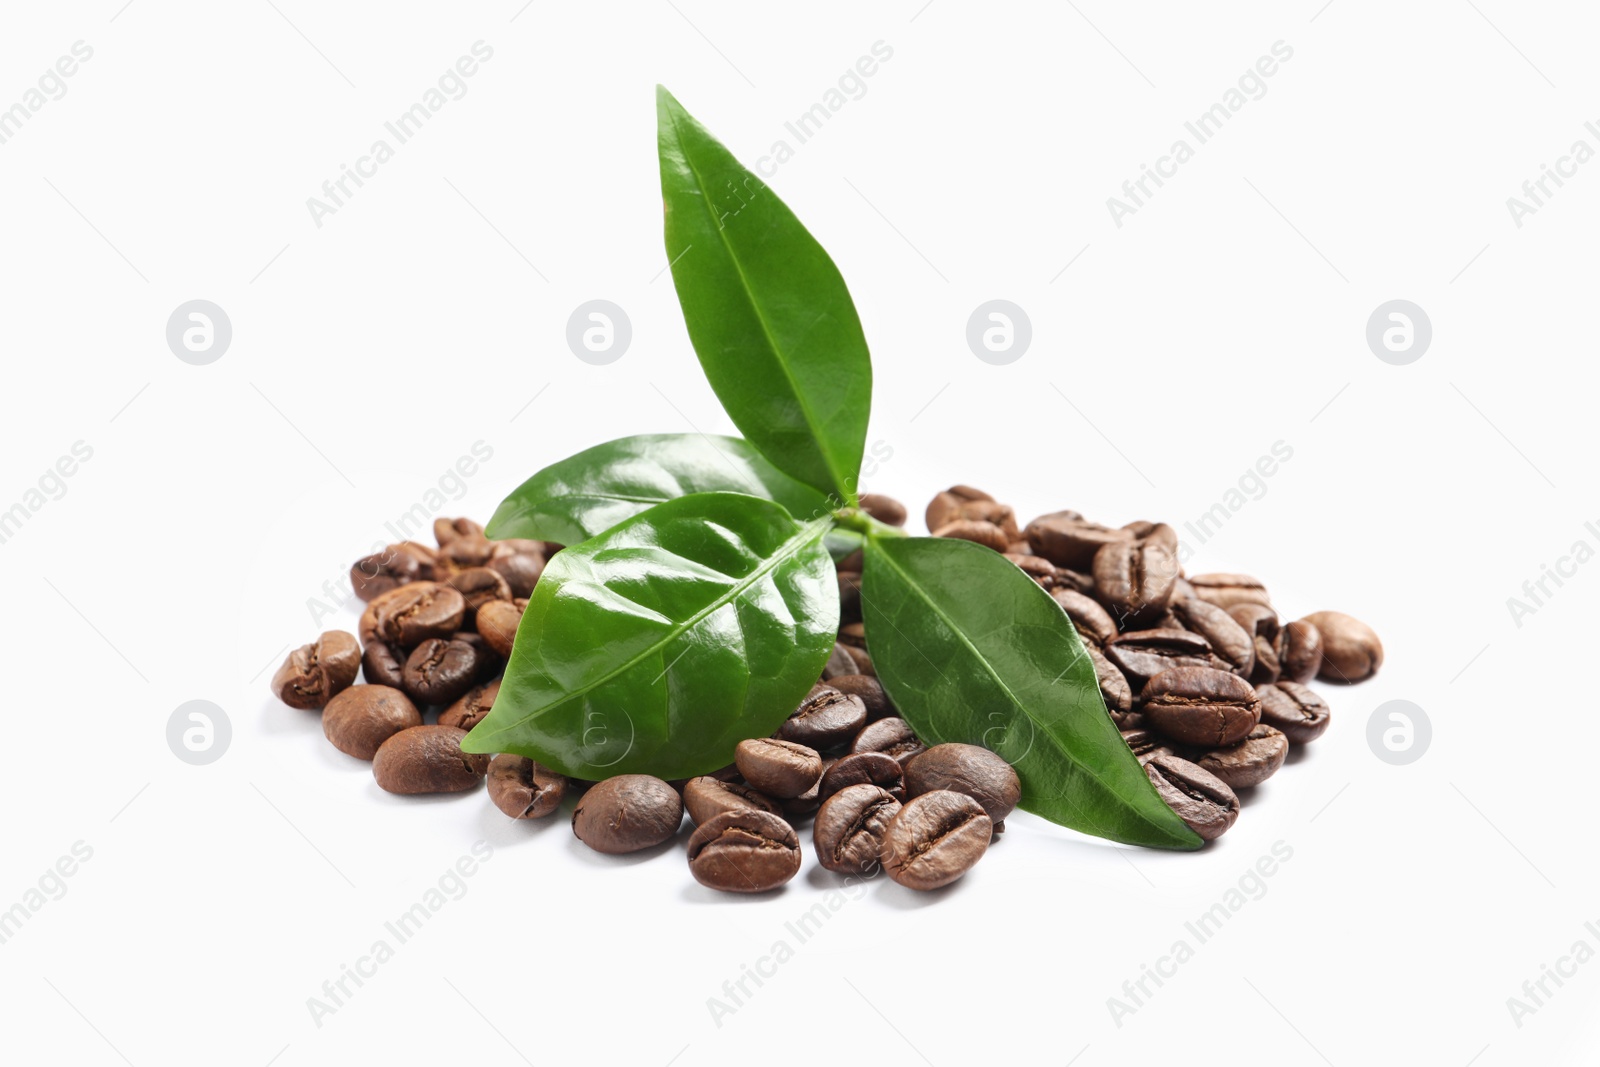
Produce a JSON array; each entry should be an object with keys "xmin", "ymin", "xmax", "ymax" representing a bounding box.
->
[{"xmin": 861, "ymin": 537, "xmax": 1203, "ymax": 849}]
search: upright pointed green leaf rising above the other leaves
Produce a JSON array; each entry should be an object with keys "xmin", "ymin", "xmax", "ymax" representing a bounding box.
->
[{"xmin": 656, "ymin": 86, "xmax": 872, "ymax": 504}]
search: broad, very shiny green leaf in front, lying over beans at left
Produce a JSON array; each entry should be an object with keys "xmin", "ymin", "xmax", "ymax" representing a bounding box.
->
[{"xmin": 461, "ymin": 493, "xmax": 838, "ymax": 779}]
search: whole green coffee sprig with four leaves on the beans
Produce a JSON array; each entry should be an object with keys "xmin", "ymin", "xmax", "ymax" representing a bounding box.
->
[{"xmin": 462, "ymin": 90, "xmax": 1202, "ymax": 848}]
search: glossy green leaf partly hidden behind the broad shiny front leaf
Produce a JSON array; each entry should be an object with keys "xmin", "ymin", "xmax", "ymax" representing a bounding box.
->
[{"xmin": 488, "ymin": 434, "xmax": 827, "ymax": 544}]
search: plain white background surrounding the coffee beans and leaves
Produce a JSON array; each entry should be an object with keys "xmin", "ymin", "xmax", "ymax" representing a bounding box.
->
[{"xmin": 0, "ymin": 0, "xmax": 1600, "ymax": 1067}]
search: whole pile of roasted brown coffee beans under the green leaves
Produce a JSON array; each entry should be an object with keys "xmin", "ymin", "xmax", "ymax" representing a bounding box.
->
[{"xmin": 272, "ymin": 486, "xmax": 1382, "ymax": 893}]
